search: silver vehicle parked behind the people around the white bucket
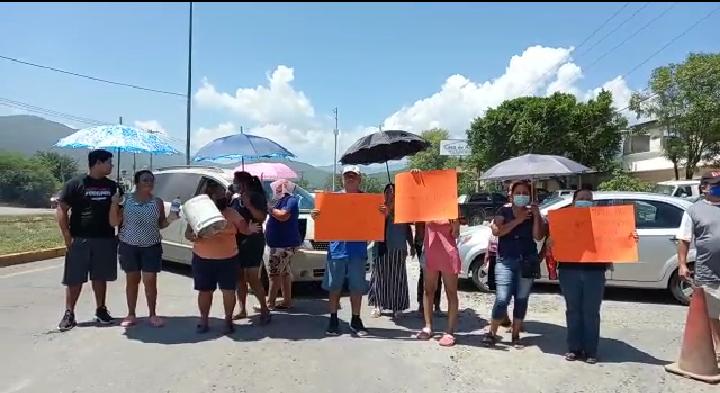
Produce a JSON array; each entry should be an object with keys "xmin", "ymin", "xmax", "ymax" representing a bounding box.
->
[{"xmin": 149, "ymin": 166, "xmax": 368, "ymax": 281}]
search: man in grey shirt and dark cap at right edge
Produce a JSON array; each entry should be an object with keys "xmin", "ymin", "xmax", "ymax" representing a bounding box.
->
[{"xmin": 677, "ymin": 170, "xmax": 720, "ymax": 349}]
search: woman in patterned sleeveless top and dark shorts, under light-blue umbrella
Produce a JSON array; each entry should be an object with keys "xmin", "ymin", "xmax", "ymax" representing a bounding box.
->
[{"xmin": 109, "ymin": 170, "xmax": 177, "ymax": 328}]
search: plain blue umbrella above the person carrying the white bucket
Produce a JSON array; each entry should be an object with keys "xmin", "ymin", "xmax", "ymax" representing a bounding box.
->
[{"xmin": 193, "ymin": 134, "xmax": 295, "ymax": 164}]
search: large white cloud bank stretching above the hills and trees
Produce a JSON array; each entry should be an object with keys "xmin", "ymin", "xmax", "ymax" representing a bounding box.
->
[{"xmin": 193, "ymin": 46, "xmax": 635, "ymax": 165}]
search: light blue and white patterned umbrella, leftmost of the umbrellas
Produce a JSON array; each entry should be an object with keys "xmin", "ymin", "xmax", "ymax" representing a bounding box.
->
[{"xmin": 55, "ymin": 124, "xmax": 180, "ymax": 181}]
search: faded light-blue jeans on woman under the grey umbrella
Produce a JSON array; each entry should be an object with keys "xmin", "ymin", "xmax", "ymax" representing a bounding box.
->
[{"xmin": 492, "ymin": 257, "xmax": 533, "ymax": 321}]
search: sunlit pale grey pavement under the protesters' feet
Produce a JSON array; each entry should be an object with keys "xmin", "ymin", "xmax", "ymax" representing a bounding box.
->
[{"xmin": 0, "ymin": 259, "xmax": 717, "ymax": 393}]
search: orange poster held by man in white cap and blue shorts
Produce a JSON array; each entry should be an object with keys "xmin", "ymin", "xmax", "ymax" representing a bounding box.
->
[{"xmin": 314, "ymin": 192, "xmax": 385, "ymax": 241}]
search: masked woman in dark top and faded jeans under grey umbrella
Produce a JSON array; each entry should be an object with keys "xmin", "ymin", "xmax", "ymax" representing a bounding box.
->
[{"xmin": 483, "ymin": 181, "xmax": 546, "ymax": 348}]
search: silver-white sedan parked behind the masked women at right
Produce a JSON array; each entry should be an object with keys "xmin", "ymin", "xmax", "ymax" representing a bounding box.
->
[{"xmin": 458, "ymin": 192, "xmax": 695, "ymax": 304}]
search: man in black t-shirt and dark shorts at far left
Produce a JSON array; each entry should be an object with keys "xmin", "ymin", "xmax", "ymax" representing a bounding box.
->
[{"xmin": 56, "ymin": 150, "xmax": 122, "ymax": 331}]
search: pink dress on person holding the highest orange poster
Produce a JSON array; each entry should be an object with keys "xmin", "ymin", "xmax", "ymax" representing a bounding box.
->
[{"xmin": 423, "ymin": 221, "xmax": 460, "ymax": 274}]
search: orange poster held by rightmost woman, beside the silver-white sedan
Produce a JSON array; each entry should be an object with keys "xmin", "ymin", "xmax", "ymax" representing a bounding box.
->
[{"xmin": 548, "ymin": 206, "xmax": 638, "ymax": 263}]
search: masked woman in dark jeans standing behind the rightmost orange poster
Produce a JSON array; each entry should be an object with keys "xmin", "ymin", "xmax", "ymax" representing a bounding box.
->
[{"xmin": 550, "ymin": 189, "xmax": 609, "ymax": 364}]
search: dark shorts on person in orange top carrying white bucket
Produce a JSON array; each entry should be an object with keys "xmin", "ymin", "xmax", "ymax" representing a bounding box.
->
[{"xmin": 192, "ymin": 254, "xmax": 238, "ymax": 291}]
